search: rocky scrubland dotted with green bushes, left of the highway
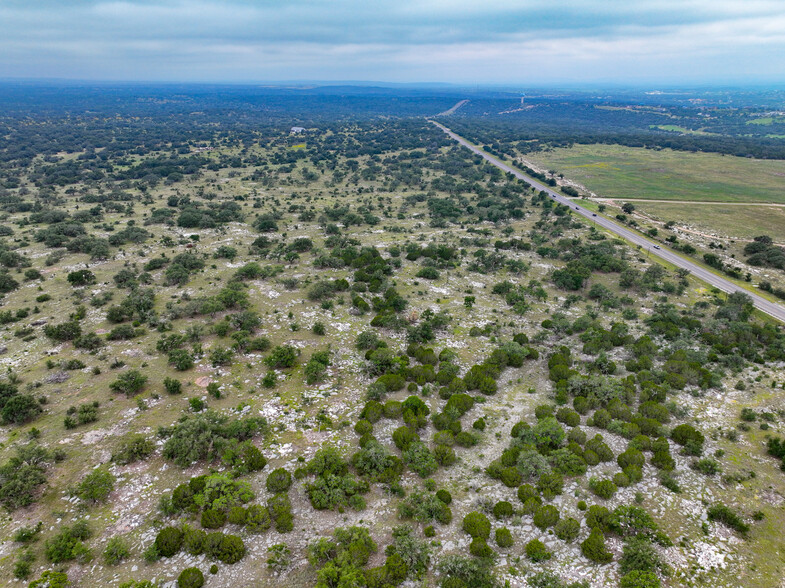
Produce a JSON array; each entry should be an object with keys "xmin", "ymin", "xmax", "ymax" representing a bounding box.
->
[{"xmin": 0, "ymin": 87, "xmax": 785, "ymax": 588}]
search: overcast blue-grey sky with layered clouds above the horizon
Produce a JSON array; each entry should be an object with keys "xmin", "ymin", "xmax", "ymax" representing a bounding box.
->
[{"xmin": 0, "ymin": 0, "xmax": 785, "ymax": 85}]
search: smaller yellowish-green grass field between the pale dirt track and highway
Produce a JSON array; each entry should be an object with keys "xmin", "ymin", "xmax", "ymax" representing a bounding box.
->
[{"xmin": 635, "ymin": 202, "xmax": 785, "ymax": 241}]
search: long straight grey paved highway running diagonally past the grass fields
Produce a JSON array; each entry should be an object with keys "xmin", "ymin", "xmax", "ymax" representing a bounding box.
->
[{"xmin": 431, "ymin": 120, "xmax": 785, "ymax": 323}]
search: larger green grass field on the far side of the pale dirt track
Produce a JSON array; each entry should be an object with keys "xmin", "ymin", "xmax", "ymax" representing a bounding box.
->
[{"xmin": 527, "ymin": 145, "xmax": 785, "ymax": 203}]
